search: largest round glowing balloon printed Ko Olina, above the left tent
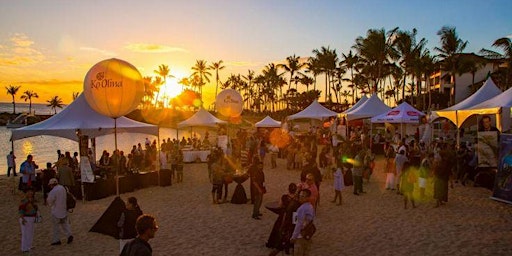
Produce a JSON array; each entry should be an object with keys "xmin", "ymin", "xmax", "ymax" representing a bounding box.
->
[{"xmin": 84, "ymin": 59, "xmax": 144, "ymax": 118}]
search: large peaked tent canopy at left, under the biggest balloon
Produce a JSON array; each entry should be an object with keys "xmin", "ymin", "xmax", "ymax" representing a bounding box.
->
[{"xmin": 12, "ymin": 94, "xmax": 158, "ymax": 141}]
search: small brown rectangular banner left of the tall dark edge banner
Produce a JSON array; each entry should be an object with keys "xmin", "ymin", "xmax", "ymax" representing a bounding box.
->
[{"xmin": 477, "ymin": 132, "xmax": 498, "ymax": 167}]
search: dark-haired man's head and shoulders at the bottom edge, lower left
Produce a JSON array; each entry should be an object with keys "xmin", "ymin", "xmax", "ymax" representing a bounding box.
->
[{"xmin": 121, "ymin": 214, "xmax": 158, "ymax": 256}]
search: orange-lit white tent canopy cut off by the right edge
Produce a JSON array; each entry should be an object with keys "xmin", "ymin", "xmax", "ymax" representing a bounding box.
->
[{"xmin": 457, "ymin": 88, "xmax": 512, "ymax": 131}]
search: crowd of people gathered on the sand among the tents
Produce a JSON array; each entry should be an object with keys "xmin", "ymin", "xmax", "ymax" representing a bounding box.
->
[{"xmin": 13, "ymin": 114, "xmax": 500, "ymax": 255}]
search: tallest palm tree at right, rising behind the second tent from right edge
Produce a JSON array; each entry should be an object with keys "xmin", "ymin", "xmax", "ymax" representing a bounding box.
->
[{"xmin": 434, "ymin": 26, "xmax": 468, "ymax": 105}]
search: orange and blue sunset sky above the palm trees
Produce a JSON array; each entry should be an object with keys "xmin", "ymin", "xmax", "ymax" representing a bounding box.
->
[{"xmin": 0, "ymin": 0, "xmax": 512, "ymax": 106}]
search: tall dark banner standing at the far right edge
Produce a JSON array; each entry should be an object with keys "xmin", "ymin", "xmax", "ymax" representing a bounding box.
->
[{"xmin": 491, "ymin": 134, "xmax": 512, "ymax": 204}]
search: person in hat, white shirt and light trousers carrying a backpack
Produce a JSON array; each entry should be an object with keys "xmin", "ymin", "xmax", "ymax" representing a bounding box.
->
[{"xmin": 47, "ymin": 178, "xmax": 73, "ymax": 245}]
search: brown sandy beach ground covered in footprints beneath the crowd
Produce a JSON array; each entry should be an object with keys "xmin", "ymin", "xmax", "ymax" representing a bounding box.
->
[{"xmin": 0, "ymin": 156, "xmax": 512, "ymax": 256}]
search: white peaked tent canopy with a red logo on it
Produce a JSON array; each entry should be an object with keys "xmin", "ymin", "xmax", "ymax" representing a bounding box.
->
[{"xmin": 371, "ymin": 102, "xmax": 425, "ymax": 124}]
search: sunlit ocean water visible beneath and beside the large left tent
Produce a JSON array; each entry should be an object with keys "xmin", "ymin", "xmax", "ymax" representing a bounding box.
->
[{"xmin": 0, "ymin": 126, "xmax": 194, "ymax": 175}]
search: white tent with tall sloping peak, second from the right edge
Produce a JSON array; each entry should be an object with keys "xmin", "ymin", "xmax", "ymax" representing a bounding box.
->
[{"xmin": 430, "ymin": 77, "xmax": 501, "ymax": 128}]
